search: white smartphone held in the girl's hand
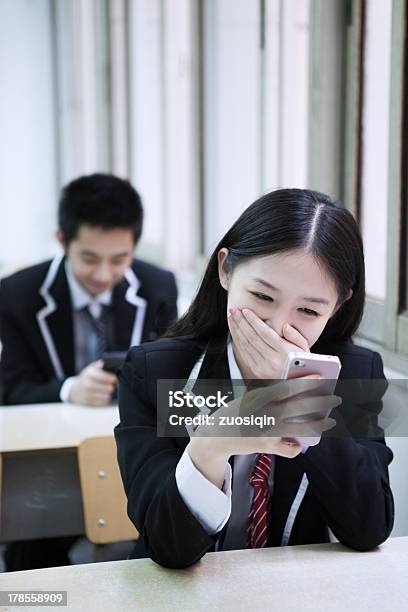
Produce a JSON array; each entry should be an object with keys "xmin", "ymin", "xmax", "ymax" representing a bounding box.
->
[{"xmin": 283, "ymin": 352, "xmax": 341, "ymax": 448}]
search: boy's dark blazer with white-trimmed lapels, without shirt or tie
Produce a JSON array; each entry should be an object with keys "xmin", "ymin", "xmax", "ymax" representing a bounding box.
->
[{"xmin": 0, "ymin": 257, "xmax": 177, "ymax": 404}]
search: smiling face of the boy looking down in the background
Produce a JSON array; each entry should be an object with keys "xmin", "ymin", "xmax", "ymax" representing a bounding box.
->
[{"xmin": 58, "ymin": 225, "xmax": 135, "ymax": 295}]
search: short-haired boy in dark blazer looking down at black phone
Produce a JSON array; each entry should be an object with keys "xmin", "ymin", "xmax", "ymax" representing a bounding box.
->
[{"xmin": 0, "ymin": 174, "xmax": 177, "ymax": 406}]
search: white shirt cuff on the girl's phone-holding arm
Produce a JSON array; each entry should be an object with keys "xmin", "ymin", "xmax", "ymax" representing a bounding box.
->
[{"xmin": 176, "ymin": 448, "xmax": 232, "ymax": 535}]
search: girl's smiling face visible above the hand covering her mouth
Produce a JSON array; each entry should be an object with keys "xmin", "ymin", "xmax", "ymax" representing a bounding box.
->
[{"xmin": 218, "ymin": 249, "xmax": 338, "ymax": 348}]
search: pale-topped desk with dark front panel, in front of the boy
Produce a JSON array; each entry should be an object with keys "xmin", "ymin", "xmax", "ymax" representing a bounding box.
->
[{"xmin": 0, "ymin": 403, "xmax": 119, "ymax": 542}]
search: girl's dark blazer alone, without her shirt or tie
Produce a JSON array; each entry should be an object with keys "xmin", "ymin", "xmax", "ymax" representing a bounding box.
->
[{"xmin": 115, "ymin": 338, "xmax": 394, "ymax": 568}]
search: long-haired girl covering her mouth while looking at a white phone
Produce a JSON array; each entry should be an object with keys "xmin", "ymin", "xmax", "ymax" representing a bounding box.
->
[{"xmin": 115, "ymin": 189, "xmax": 393, "ymax": 568}]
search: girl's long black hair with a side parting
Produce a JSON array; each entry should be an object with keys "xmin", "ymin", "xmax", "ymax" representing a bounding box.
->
[{"xmin": 166, "ymin": 189, "xmax": 365, "ymax": 343}]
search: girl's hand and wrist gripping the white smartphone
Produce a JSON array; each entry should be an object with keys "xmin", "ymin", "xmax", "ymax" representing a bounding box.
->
[{"xmin": 188, "ymin": 375, "xmax": 341, "ymax": 488}]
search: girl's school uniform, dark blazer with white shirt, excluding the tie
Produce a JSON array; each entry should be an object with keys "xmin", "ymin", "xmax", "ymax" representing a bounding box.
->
[{"xmin": 115, "ymin": 337, "xmax": 394, "ymax": 568}]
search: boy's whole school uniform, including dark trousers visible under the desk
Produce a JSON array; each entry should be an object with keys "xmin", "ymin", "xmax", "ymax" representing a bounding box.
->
[{"xmin": 0, "ymin": 256, "xmax": 177, "ymax": 571}]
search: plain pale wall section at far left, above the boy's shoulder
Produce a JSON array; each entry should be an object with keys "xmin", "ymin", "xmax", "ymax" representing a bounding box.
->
[{"xmin": 0, "ymin": 0, "xmax": 57, "ymax": 275}]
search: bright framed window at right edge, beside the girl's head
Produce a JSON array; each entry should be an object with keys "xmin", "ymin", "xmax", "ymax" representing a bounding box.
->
[{"xmin": 344, "ymin": 0, "xmax": 408, "ymax": 374}]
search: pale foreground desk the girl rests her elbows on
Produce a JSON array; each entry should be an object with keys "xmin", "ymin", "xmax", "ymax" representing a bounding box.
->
[{"xmin": 0, "ymin": 538, "xmax": 408, "ymax": 612}]
